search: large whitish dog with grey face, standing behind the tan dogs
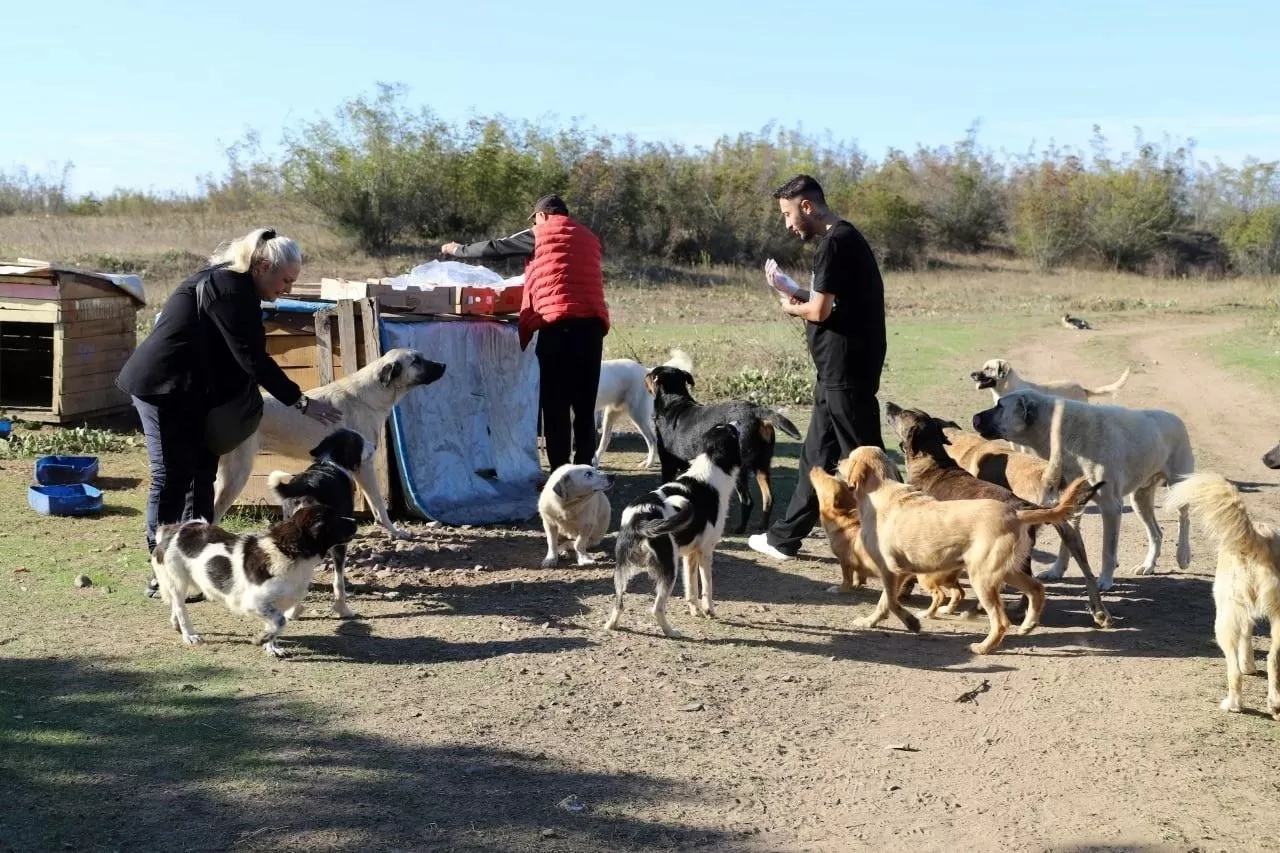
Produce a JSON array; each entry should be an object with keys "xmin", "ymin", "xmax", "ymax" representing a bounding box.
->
[{"xmin": 973, "ymin": 388, "xmax": 1196, "ymax": 592}]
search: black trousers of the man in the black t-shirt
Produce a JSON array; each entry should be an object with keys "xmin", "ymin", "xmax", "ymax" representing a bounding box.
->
[{"xmin": 768, "ymin": 383, "xmax": 884, "ymax": 553}]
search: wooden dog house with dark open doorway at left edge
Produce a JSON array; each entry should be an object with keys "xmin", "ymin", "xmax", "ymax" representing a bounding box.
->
[{"xmin": 0, "ymin": 260, "xmax": 146, "ymax": 424}]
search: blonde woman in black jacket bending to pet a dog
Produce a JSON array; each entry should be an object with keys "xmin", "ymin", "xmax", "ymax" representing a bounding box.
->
[{"xmin": 115, "ymin": 228, "xmax": 342, "ymax": 589}]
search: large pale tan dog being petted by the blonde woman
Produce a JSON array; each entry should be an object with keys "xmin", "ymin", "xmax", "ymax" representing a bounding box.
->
[{"xmin": 214, "ymin": 348, "xmax": 444, "ymax": 539}]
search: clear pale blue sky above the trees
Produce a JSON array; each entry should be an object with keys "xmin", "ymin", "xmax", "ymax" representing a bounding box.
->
[{"xmin": 0, "ymin": 0, "xmax": 1280, "ymax": 192}]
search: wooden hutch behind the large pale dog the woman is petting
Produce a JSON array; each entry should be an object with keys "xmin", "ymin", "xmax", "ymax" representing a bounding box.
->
[{"xmin": 237, "ymin": 298, "xmax": 390, "ymax": 512}]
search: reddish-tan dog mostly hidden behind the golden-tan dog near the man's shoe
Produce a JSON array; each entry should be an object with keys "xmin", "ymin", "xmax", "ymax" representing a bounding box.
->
[{"xmin": 809, "ymin": 457, "xmax": 964, "ymax": 619}]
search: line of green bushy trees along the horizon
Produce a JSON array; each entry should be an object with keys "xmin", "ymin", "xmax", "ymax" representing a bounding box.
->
[{"xmin": 0, "ymin": 86, "xmax": 1280, "ymax": 275}]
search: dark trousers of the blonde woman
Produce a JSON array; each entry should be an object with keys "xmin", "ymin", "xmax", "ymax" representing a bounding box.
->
[{"xmin": 133, "ymin": 397, "xmax": 218, "ymax": 552}]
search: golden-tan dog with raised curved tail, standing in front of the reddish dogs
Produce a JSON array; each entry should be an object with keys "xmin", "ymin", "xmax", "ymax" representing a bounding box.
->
[{"xmin": 849, "ymin": 447, "xmax": 1093, "ymax": 654}]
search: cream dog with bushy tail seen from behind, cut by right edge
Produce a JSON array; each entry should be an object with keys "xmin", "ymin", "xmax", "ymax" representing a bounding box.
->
[{"xmin": 1165, "ymin": 473, "xmax": 1280, "ymax": 721}]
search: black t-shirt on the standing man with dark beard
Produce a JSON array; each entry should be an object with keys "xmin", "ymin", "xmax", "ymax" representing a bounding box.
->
[{"xmin": 805, "ymin": 219, "xmax": 886, "ymax": 388}]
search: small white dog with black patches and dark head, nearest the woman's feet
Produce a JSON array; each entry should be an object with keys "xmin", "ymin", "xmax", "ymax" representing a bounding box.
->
[{"xmin": 151, "ymin": 506, "xmax": 356, "ymax": 657}]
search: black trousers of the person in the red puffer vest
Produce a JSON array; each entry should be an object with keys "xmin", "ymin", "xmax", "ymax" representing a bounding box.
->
[{"xmin": 536, "ymin": 319, "xmax": 604, "ymax": 471}]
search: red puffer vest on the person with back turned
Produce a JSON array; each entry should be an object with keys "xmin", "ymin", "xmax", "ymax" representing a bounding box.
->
[{"xmin": 520, "ymin": 215, "xmax": 609, "ymax": 350}]
